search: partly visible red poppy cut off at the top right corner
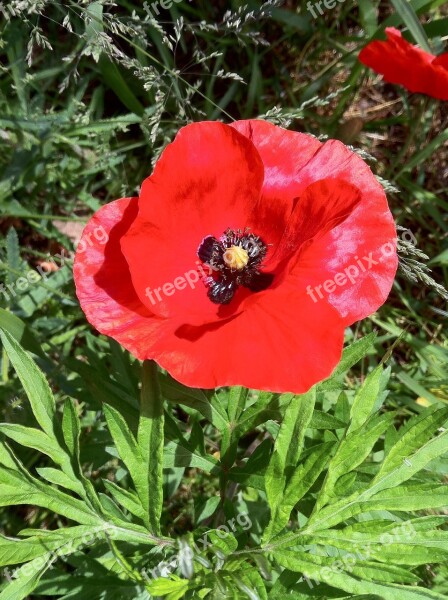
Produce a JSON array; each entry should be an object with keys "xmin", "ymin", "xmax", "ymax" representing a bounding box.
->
[{"xmin": 359, "ymin": 27, "xmax": 448, "ymax": 100}]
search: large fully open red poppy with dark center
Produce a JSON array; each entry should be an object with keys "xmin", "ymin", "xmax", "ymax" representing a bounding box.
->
[{"xmin": 74, "ymin": 120, "xmax": 397, "ymax": 393}]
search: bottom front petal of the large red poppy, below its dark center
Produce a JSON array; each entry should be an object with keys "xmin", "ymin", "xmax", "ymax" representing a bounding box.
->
[{"xmin": 152, "ymin": 285, "xmax": 344, "ymax": 394}]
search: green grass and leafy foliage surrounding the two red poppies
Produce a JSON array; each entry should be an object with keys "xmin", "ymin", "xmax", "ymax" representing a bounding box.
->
[{"xmin": 0, "ymin": 0, "xmax": 448, "ymax": 600}]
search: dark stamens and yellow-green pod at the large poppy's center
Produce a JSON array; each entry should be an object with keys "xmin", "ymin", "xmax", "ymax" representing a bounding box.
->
[{"xmin": 198, "ymin": 229, "xmax": 274, "ymax": 304}]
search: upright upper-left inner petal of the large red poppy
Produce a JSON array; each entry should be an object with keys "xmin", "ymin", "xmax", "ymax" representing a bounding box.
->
[{"xmin": 122, "ymin": 122, "xmax": 270, "ymax": 324}]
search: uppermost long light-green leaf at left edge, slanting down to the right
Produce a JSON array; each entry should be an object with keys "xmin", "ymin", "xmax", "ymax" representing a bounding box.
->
[{"xmin": 0, "ymin": 330, "xmax": 56, "ymax": 439}]
